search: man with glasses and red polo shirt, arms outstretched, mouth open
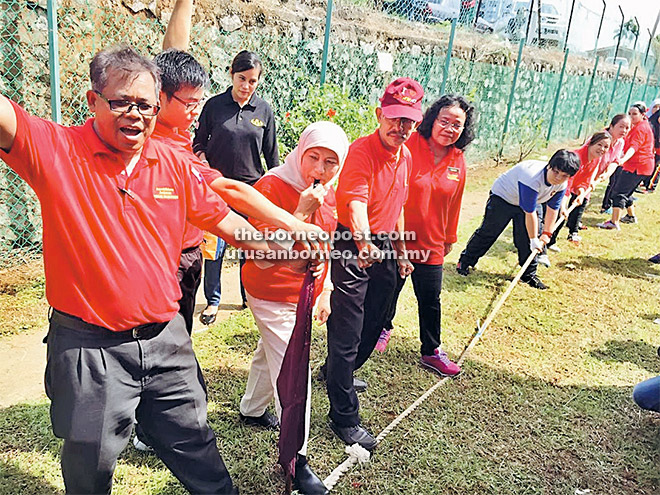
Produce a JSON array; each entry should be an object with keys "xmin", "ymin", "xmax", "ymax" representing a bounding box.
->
[{"xmin": 0, "ymin": 47, "xmax": 284, "ymax": 494}]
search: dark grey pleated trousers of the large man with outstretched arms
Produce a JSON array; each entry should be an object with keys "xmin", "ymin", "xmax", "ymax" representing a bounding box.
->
[{"xmin": 46, "ymin": 311, "xmax": 236, "ymax": 494}]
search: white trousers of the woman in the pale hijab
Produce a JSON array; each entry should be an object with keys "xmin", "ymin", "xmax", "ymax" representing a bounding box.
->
[{"xmin": 240, "ymin": 293, "xmax": 312, "ymax": 455}]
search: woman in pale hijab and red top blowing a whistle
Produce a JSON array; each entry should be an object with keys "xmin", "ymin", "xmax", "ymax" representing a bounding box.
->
[{"xmin": 240, "ymin": 122, "xmax": 349, "ymax": 494}]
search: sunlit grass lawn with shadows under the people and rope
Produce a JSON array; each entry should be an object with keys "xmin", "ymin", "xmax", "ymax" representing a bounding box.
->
[{"xmin": 0, "ymin": 166, "xmax": 660, "ymax": 495}]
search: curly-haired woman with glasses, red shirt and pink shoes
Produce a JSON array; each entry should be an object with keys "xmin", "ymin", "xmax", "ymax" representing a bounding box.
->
[{"xmin": 376, "ymin": 95, "xmax": 476, "ymax": 376}]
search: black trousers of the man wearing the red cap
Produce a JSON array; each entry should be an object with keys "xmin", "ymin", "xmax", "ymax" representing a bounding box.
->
[{"xmin": 326, "ymin": 226, "xmax": 398, "ymax": 426}]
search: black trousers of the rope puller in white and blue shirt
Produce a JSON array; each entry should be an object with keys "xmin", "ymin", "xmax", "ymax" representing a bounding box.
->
[{"xmin": 459, "ymin": 194, "xmax": 537, "ymax": 282}]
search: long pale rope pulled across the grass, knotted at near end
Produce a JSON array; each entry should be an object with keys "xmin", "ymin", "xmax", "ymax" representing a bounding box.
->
[{"xmin": 323, "ymin": 174, "xmax": 611, "ymax": 490}]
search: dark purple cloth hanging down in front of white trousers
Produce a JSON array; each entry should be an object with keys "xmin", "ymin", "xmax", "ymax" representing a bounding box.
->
[{"xmin": 277, "ymin": 270, "xmax": 314, "ymax": 485}]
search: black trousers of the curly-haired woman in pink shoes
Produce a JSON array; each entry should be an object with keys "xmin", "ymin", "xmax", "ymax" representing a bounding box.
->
[{"xmin": 383, "ymin": 263, "xmax": 442, "ymax": 356}]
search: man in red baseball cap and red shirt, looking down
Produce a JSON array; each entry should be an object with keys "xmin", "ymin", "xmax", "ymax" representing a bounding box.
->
[{"xmin": 322, "ymin": 77, "xmax": 424, "ymax": 450}]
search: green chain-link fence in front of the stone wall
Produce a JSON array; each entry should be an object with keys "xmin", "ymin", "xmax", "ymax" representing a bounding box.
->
[{"xmin": 0, "ymin": 0, "xmax": 659, "ymax": 268}]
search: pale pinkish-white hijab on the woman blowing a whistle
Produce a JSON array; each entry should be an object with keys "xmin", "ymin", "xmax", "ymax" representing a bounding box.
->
[{"xmin": 266, "ymin": 121, "xmax": 349, "ymax": 193}]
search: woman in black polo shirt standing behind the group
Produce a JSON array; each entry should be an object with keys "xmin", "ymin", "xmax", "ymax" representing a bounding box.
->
[{"xmin": 193, "ymin": 51, "xmax": 279, "ymax": 325}]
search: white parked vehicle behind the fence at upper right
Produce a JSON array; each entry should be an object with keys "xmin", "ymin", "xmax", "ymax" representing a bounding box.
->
[{"xmin": 493, "ymin": 0, "xmax": 566, "ymax": 45}]
